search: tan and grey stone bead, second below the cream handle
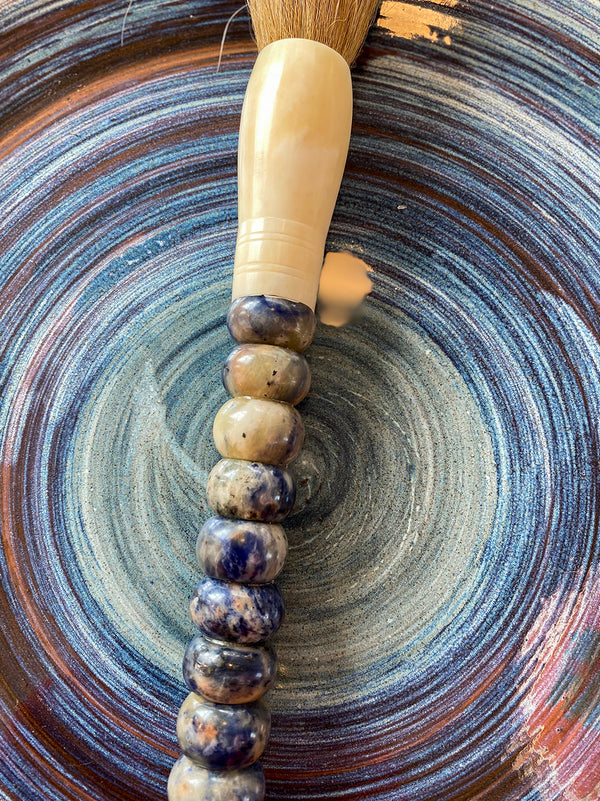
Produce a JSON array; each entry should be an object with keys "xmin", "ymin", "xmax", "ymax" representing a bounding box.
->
[{"xmin": 223, "ymin": 345, "xmax": 310, "ymax": 406}]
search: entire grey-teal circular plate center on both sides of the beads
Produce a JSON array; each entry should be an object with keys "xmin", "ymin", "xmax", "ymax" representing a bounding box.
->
[{"xmin": 67, "ymin": 286, "xmax": 496, "ymax": 710}]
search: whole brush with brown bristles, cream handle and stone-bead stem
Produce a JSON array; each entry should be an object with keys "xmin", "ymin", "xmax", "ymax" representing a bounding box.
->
[{"xmin": 168, "ymin": 0, "xmax": 379, "ymax": 801}]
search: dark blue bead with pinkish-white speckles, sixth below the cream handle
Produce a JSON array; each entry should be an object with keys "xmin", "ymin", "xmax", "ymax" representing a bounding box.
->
[{"xmin": 190, "ymin": 577, "xmax": 284, "ymax": 645}]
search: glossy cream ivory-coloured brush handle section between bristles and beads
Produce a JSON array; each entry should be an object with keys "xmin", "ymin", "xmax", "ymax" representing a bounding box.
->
[{"xmin": 233, "ymin": 39, "xmax": 352, "ymax": 309}]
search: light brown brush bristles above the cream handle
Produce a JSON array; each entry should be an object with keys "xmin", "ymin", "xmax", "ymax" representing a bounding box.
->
[{"xmin": 247, "ymin": 0, "xmax": 381, "ymax": 64}]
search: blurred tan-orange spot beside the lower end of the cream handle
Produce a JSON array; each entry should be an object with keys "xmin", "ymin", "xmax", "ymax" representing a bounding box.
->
[{"xmin": 318, "ymin": 253, "xmax": 373, "ymax": 326}]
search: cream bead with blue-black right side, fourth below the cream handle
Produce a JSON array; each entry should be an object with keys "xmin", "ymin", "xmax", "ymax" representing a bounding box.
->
[{"xmin": 206, "ymin": 459, "xmax": 296, "ymax": 523}]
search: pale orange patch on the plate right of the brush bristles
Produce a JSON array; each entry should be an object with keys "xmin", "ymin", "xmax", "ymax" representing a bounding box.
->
[{"xmin": 377, "ymin": 0, "xmax": 461, "ymax": 45}]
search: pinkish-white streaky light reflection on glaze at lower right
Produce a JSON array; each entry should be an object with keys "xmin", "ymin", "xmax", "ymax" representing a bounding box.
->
[{"xmin": 514, "ymin": 569, "xmax": 600, "ymax": 801}]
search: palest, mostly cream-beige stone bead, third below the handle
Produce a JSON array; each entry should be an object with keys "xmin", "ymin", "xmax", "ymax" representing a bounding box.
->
[{"xmin": 213, "ymin": 398, "xmax": 304, "ymax": 465}]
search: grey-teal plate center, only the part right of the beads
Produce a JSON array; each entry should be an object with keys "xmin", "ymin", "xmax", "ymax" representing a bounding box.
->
[{"xmin": 272, "ymin": 299, "xmax": 497, "ymax": 708}]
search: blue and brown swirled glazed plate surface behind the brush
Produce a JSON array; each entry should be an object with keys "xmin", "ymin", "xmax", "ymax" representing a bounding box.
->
[{"xmin": 0, "ymin": 0, "xmax": 600, "ymax": 801}]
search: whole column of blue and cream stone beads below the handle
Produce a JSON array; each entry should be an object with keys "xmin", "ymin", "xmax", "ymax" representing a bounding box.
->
[{"xmin": 169, "ymin": 295, "xmax": 315, "ymax": 801}]
